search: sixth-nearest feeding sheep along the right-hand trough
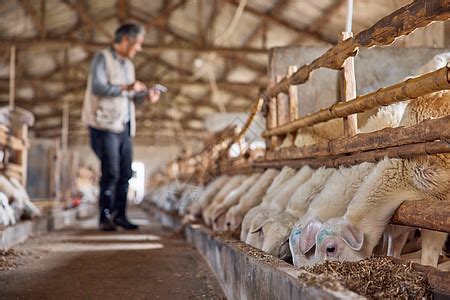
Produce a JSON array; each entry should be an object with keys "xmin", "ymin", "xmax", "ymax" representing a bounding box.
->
[{"xmin": 225, "ymin": 169, "xmax": 279, "ymax": 231}]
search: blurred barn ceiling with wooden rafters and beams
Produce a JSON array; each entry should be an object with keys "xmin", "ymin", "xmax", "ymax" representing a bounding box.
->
[{"xmin": 0, "ymin": 0, "xmax": 408, "ymax": 144}]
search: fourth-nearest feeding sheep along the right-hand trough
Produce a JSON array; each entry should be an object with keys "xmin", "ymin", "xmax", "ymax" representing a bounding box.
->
[{"xmin": 246, "ymin": 166, "xmax": 313, "ymax": 249}]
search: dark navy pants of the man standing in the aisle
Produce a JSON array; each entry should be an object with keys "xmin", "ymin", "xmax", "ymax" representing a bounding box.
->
[{"xmin": 89, "ymin": 123, "xmax": 133, "ymax": 222}]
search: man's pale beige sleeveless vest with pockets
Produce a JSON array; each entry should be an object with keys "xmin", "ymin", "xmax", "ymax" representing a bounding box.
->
[{"xmin": 81, "ymin": 48, "xmax": 136, "ymax": 136}]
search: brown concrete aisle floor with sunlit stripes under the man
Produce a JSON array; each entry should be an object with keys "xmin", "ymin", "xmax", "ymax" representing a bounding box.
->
[{"xmin": 0, "ymin": 209, "xmax": 225, "ymax": 299}]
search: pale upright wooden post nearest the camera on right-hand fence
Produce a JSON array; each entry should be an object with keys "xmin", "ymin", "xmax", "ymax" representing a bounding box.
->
[{"xmin": 340, "ymin": 32, "xmax": 358, "ymax": 137}]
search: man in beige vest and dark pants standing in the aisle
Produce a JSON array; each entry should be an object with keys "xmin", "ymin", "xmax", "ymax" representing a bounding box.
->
[{"xmin": 82, "ymin": 24, "xmax": 160, "ymax": 231}]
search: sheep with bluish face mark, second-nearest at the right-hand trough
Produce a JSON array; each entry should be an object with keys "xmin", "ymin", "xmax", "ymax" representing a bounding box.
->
[{"xmin": 289, "ymin": 163, "xmax": 373, "ymax": 266}]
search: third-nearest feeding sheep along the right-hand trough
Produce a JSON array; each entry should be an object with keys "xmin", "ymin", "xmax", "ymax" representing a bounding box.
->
[{"xmin": 255, "ymin": 167, "xmax": 336, "ymax": 258}]
